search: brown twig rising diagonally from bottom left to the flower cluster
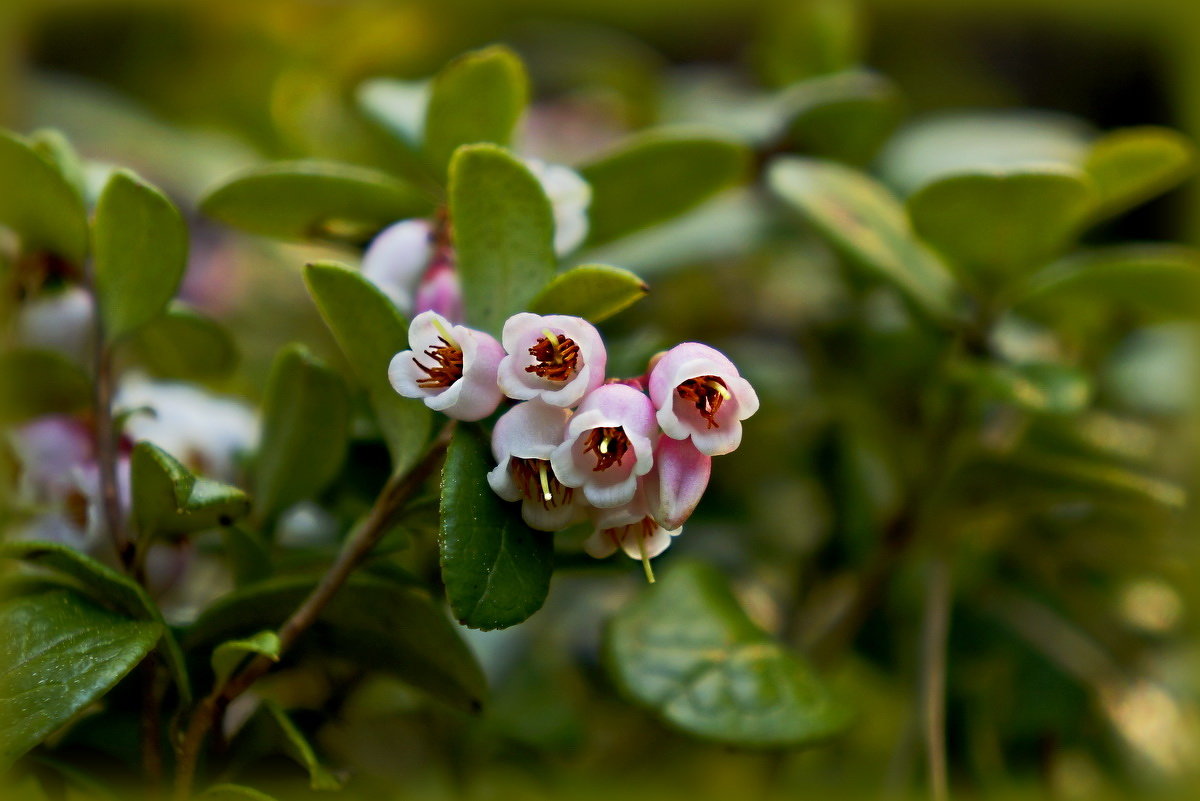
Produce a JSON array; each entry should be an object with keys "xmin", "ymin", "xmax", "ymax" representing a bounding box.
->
[{"xmin": 175, "ymin": 423, "xmax": 454, "ymax": 801}]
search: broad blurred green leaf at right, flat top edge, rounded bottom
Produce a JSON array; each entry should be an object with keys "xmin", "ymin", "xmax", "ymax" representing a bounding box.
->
[{"xmin": 908, "ymin": 167, "xmax": 1094, "ymax": 279}]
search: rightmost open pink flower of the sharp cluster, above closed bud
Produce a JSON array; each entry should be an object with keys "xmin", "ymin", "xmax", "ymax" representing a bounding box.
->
[{"xmin": 650, "ymin": 342, "xmax": 758, "ymax": 456}]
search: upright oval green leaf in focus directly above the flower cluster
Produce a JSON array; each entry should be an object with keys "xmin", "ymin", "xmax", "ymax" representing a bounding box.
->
[{"xmin": 450, "ymin": 145, "xmax": 557, "ymax": 336}]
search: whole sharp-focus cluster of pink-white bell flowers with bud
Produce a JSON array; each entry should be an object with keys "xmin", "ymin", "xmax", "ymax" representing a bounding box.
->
[{"xmin": 389, "ymin": 311, "xmax": 758, "ymax": 582}]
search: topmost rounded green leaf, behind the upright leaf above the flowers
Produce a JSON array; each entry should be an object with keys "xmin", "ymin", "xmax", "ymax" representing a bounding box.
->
[{"xmin": 424, "ymin": 47, "xmax": 529, "ymax": 174}]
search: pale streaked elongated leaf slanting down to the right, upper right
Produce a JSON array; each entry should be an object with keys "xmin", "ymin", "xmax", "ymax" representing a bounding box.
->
[{"xmin": 768, "ymin": 157, "xmax": 956, "ymax": 320}]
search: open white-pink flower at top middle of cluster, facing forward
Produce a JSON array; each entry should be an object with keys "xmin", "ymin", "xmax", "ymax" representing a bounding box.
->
[{"xmin": 499, "ymin": 312, "xmax": 607, "ymax": 408}]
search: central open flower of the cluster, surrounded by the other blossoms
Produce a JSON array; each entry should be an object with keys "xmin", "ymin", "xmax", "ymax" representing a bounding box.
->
[{"xmin": 550, "ymin": 384, "xmax": 655, "ymax": 508}]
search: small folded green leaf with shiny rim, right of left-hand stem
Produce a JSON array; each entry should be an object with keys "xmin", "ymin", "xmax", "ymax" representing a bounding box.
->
[{"xmin": 131, "ymin": 441, "xmax": 250, "ymax": 540}]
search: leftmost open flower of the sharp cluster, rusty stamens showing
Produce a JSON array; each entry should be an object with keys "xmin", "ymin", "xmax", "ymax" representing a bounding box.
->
[{"xmin": 388, "ymin": 312, "xmax": 504, "ymax": 421}]
